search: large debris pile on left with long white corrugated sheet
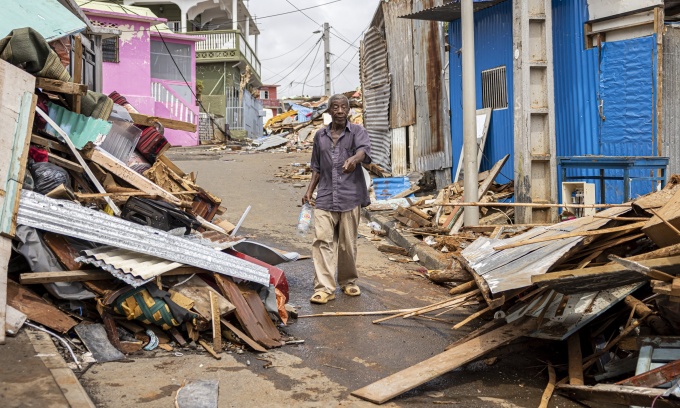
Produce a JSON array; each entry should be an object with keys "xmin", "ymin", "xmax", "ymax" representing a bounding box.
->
[{"xmin": 0, "ymin": 34, "xmax": 297, "ymax": 365}]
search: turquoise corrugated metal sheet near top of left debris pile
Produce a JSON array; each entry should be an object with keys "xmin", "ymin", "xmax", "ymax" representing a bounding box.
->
[{"xmin": 45, "ymin": 102, "xmax": 111, "ymax": 149}]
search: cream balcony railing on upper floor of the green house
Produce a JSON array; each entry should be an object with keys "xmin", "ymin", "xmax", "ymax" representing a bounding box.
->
[{"xmin": 186, "ymin": 30, "xmax": 261, "ymax": 79}]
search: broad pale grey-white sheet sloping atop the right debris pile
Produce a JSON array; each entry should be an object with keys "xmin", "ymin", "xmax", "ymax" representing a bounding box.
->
[{"xmin": 461, "ymin": 207, "xmax": 630, "ymax": 294}]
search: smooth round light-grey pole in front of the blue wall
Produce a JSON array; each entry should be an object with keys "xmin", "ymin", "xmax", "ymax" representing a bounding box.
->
[{"xmin": 461, "ymin": 0, "xmax": 480, "ymax": 226}]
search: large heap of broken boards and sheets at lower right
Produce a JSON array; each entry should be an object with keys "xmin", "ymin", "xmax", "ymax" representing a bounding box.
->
[{"xmin": 352, "ymin": 176, "xmax": 680, "ymax": 407}]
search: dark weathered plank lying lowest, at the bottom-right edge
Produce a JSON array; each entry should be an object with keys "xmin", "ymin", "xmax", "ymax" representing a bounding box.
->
[{"xmin": 557, "ymin": 384, "xmax": 680, "ymax": 408}]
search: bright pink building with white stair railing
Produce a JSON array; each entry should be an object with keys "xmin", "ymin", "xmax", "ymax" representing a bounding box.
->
[{"xmin": 81, "ymin": 1, "xmax": 203, "ymax": 146}]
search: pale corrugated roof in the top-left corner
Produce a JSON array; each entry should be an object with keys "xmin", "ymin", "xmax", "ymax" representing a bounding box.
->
[{"xmin": 0, "ymin": 0, "xmax": 86, "ymax": 42}]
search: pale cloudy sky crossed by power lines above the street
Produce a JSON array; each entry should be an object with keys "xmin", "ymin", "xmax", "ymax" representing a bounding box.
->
[{"xmin": 249, "ymin": 0, "xmax": 380, "ymax": 98}]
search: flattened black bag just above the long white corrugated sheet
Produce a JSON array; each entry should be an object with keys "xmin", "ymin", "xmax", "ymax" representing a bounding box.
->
[{"xmin": 121, "ymin": 197, "xmax": 201, "ymax": 235}]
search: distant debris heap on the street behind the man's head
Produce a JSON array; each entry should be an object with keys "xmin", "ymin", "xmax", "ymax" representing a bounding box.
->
[{"xmin": 254, "ymin": 91, "xmax": 363, "ymax": 150}]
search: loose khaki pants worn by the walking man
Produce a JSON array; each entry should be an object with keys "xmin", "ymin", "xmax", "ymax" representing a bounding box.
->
[{"xmin": 312, "ymin": 206, "xmax": 360, "ymax": 293}]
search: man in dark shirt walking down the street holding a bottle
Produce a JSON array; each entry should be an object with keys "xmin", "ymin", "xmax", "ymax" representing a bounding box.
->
[{"xmin": 302, "ymin": 94, "xmax": 371, "ymax": 304}]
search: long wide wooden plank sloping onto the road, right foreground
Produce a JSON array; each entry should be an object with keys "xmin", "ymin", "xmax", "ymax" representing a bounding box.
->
[{"xmin": 352, "ymin": 321, "xmax": 535, "ymax": 404}]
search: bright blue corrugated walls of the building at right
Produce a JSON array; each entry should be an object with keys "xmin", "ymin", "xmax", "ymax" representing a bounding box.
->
[{"xmin": 449, "ymin": 0, "xmax": 657, "ymax": 203}]
